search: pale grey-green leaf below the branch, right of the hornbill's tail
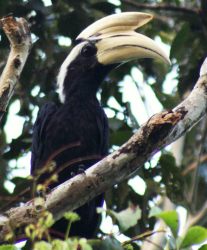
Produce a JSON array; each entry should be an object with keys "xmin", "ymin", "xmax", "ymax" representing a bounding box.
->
[{"xmin": 111, "ymin": 207, "xmax": 141, "ymax": 231}]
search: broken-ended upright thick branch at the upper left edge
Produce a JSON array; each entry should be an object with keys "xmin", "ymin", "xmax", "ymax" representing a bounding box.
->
[{"xmin": 0, "ymin": 16, "xmax": 31, "ymax": 120}]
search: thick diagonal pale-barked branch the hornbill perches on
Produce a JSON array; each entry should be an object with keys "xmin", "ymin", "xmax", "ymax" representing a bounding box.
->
[{"xmin": 0, "ymin": 59, "xmax": 207, "ymax": 241}]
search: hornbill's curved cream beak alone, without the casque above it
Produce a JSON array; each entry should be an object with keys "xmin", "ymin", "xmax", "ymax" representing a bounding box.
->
[{"xmin": 96, "ymin": 32, "xmax": 170, "ymax": 65}]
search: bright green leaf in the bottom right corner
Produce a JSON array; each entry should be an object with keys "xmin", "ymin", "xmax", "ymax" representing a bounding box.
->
[{"xmin": 181, "ymin": 226, "xmax": 207, "ymax": 248}]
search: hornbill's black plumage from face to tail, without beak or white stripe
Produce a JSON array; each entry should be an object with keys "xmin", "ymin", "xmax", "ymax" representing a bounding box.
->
[{"xmin": 31, "ymin": 43, "xmax": 113, "ymax": 238}]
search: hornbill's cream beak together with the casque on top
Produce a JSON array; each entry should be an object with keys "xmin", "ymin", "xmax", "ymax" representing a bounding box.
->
[{"xmin": 77, "ymin": 12, "xmax": 170, "ymax": 65}]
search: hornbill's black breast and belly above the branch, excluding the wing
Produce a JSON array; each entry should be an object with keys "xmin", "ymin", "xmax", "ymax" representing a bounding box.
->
[{"xmin": 40, "ymin": 99, "xmax": 108, "ymax": 180}]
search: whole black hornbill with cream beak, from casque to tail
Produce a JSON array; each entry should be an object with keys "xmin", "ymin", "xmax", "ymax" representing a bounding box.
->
[{"xmin": 31, "ymin": 12, "xmax": 169, "ymax": 238}]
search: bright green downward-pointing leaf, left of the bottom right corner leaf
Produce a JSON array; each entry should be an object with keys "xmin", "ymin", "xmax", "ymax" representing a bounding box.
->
[{"xmin": 155, "ymin": 210, "xmax": 179, "ymax": 238}]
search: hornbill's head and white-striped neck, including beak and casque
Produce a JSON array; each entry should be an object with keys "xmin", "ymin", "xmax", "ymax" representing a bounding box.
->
[{"xmin": 57, "ymin": 12, "xmax": 170, "ymax": 102}]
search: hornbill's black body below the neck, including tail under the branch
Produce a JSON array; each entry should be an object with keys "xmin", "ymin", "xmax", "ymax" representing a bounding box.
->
[{"xmin": 32, "ymin": 92, "xmax": 108, "ymax": 238}]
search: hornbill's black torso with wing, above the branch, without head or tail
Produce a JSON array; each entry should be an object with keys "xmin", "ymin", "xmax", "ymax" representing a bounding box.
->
[{"xmin": 32, "ymin": 98, "xmax": 108, "ymax": 177}]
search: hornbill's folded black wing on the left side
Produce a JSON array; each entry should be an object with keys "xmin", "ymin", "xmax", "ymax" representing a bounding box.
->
[{"xmin": 31, "ymin": 102, "xmax": 57, "ymax": 174}]
